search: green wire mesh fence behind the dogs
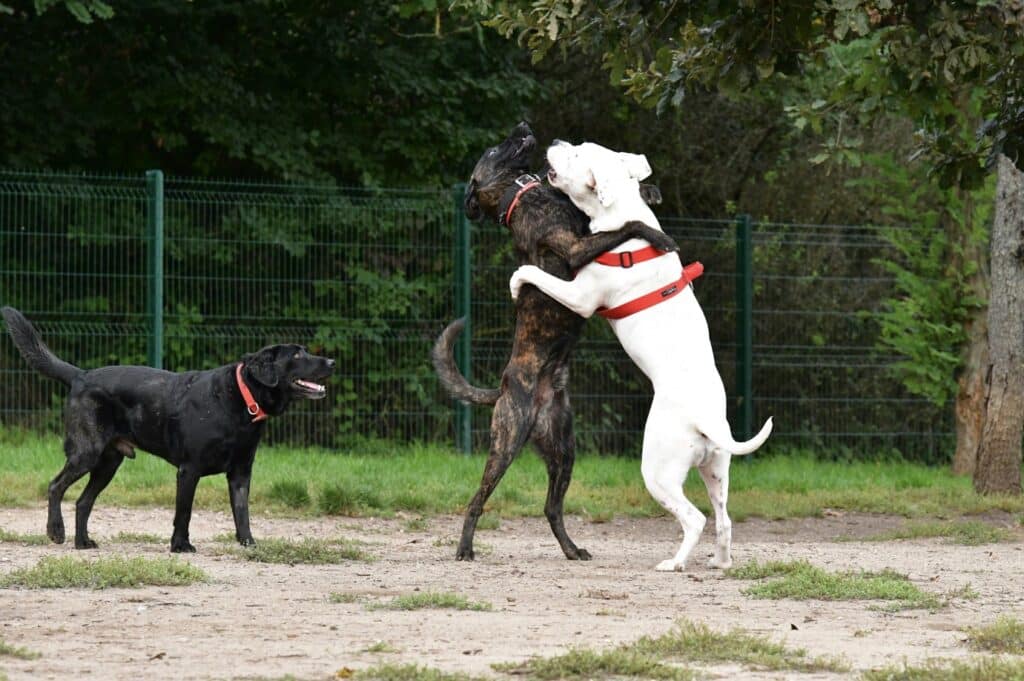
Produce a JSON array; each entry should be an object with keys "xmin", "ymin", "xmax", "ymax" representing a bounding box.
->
[{"xmin": 0, "ymin": 171, "xmax": 952, "ymax": 461}]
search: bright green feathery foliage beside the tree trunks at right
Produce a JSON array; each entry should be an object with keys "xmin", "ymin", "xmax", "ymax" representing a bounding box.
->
[{"xmin": 850, "ymin": 155, "xmax": 992, "ymax": 407}]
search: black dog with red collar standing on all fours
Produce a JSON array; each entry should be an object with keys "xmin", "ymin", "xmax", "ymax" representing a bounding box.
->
[{"xmin": 3, "ymin": 307, "xmax": 334, "ymax": 552}]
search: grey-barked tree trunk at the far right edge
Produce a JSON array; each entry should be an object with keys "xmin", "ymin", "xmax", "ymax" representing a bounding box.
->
[{"xmin": 974, "ymin": 156, "xmax": 1024, "ymax": 495}]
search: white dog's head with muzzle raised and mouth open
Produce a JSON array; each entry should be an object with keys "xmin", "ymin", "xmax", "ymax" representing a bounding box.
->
[{"xmin": 548, "ymin": 139, "xmax": 650, "ymax": 218}]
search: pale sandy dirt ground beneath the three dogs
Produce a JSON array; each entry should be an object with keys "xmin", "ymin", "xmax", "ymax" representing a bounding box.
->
[{"xmin": 0, "ymin": 506, "xmax": 1024, "ymax": 681}]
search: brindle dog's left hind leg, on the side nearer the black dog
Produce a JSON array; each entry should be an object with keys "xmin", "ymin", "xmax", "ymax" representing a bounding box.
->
[{"xmin": 455, "ymin": 374, "xmax": 537, "ymax": 560}]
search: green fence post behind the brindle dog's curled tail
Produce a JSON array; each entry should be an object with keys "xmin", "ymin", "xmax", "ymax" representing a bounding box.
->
[{"xmin": 452, "ymin": 182, "xmax": 473, "ymax": 454}]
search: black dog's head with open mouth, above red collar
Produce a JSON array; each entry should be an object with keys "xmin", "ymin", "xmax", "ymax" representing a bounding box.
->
[{"xmin": 242, "ymin": 344, "xmax": 334, "ymax": 399}]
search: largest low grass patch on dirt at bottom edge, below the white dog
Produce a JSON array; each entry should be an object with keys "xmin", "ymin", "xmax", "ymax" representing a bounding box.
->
[{"xmin": 495, "ymin": 622, "xmax": 848, "ymax": 681}]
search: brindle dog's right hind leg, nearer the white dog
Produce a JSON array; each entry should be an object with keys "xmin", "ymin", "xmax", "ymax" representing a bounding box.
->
[{"xmin": 534, "ymin": 372, "xmax": 590, "ymax": 560}]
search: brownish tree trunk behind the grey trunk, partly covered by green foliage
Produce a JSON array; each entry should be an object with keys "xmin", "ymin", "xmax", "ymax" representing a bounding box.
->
[{"xmin": 947, "ymin": 189, "xmax": 988, "ymax": 475}]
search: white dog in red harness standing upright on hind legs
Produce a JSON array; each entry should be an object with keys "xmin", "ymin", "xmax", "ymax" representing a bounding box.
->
[{"xmin": 509, "ymin": 140, "xmax": 772, "ymax": 571}]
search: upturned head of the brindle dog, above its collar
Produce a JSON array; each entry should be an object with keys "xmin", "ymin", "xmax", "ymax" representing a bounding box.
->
[{"xmin": 464, "ymin": 123, "xmax": 537, "ymax": 220}]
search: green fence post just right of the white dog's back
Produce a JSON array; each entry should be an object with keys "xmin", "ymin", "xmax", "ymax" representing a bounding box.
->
[{"xmin": 735, "ymin": 214, "xmax": 754, "ymax": 440}]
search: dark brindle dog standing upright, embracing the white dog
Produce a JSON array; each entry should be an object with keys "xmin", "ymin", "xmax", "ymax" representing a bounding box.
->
[{"xmin": 431, "ymin": 123, "xmax": 679, "ymax": 560}]
